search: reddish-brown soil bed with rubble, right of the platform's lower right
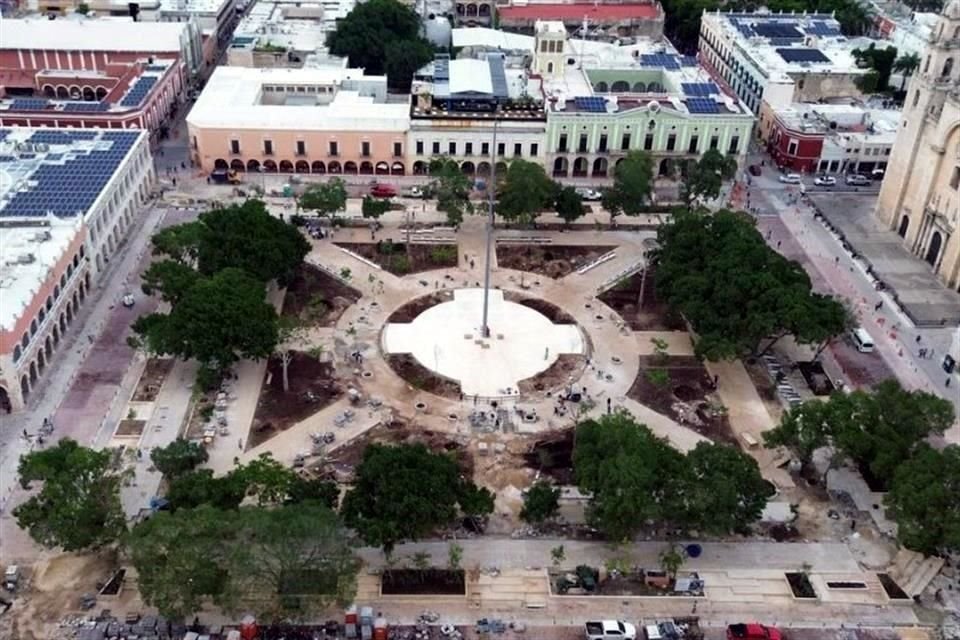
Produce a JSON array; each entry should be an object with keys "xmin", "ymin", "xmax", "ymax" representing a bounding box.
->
[{"xmin": 627, "ymin": 355, "xmax": 739, "ymax": 446}]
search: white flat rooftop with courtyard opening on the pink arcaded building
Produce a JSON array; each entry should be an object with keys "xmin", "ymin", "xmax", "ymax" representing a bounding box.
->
[{"xmin": 187, "ymin": 67, "xmax": 410, "ymax": 131}]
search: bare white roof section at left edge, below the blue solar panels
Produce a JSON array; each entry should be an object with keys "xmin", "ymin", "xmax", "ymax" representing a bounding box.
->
[{"xmin": 0, "ymin": 219, "xmax": 82, "ymax": 331}]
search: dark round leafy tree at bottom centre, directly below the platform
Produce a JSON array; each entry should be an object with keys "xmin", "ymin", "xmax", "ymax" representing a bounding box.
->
[{"xmin": 341, "ymin": 444, "xmax": 492, "ymax": 555}]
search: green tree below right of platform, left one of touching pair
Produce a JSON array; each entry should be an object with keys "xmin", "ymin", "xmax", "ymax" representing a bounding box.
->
[{"xmin": 573, "ymin": 412, "xmax": 683, "ymax": 541}]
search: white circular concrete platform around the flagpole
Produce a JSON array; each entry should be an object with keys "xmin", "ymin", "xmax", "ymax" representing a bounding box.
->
[{"xmin": 383, "ymin": 289, "xmax": 584, "ymax": 396}]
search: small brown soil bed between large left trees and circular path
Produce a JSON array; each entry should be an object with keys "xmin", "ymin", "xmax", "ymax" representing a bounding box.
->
[{"xmin": 283, "ymin": 263, "xmax": 361, "ymax": 327}]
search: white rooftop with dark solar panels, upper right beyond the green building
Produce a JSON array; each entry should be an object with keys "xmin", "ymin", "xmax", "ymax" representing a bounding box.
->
[{"xmin": 702, "ymin": 12, "xmax": 872, "ymax": 80}]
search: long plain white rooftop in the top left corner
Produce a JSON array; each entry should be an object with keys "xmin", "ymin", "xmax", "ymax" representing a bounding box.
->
[{"xmin": 0, "ymin": 16, "xmax": 187, "ymax": 53}]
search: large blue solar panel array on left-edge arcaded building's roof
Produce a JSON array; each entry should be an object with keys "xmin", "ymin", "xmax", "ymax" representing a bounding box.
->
[{"xmin": 0, "ymin": 130, "xmax": 140, "ymax": 218}]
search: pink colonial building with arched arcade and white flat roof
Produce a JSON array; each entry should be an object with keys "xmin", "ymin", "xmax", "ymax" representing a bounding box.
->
[{"xmin": 187, "ymin": 67, "xmax": 410, "ymax": 175}]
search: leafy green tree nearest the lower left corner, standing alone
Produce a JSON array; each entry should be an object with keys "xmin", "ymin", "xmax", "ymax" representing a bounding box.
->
[{"xmin": 13, "ymin": 438, "xmax": 126, "ymax": 551}]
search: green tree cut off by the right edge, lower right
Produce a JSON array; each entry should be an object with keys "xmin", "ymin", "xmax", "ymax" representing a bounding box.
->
[{"xmin": 884, "ymin": 443, "xmax": 960, "ymax": 555}]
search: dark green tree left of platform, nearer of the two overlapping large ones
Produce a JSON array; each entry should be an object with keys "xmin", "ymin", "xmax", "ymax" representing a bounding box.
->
[{"xmin": 133, "ymin": 269, "xmax": 278, "ymax": 370}]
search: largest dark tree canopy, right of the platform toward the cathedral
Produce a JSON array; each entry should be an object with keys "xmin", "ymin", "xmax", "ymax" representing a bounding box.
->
[{"xmin": 651, "ymin": 211, "xmax": 849, "ymax": 360}]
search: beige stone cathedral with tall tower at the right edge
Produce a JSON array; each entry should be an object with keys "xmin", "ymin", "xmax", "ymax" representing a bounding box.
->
[{"xmin": 876, "ymin": 0, "xmax": 960, "ymax": 291}]
